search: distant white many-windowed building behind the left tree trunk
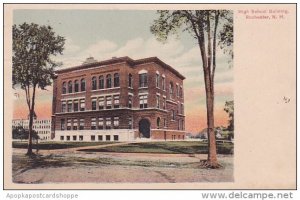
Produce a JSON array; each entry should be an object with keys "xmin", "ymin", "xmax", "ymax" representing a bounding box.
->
[{"xmin": 12, "ymin": 119, "xmax": 51, "ymax": 140}]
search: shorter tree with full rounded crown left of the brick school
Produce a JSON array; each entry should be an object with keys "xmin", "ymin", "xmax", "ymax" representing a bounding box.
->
[{"xmin": 12, "ymin": 23, "xmax": 65, "ymax": 155}]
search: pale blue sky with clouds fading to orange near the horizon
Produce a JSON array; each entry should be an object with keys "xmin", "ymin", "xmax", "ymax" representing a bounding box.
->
[{"xmin": 13, "ymin": 10, "xmax": 233, "ymax": 132}]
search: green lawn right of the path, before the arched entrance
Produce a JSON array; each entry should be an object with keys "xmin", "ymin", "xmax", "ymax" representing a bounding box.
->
[{"xmin": 81, "ymin": 141, "xmax": 233, "ymax": 154}]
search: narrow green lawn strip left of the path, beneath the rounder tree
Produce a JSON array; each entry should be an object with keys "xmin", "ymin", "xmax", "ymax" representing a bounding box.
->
[{"xmin": 12, "ymin": 141, "xmax": 115, "ymax": 150}]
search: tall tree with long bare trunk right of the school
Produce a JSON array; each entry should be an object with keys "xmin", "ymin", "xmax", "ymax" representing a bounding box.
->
[{"xmin": 150, "ymin": 10, "xmax": 233, "ymax": 168}]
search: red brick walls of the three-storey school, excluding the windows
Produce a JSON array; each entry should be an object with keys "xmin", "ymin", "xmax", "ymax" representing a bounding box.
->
[{"xmin": 52, "ymin": 56, "xmax": 184, "ymax": 139}]
